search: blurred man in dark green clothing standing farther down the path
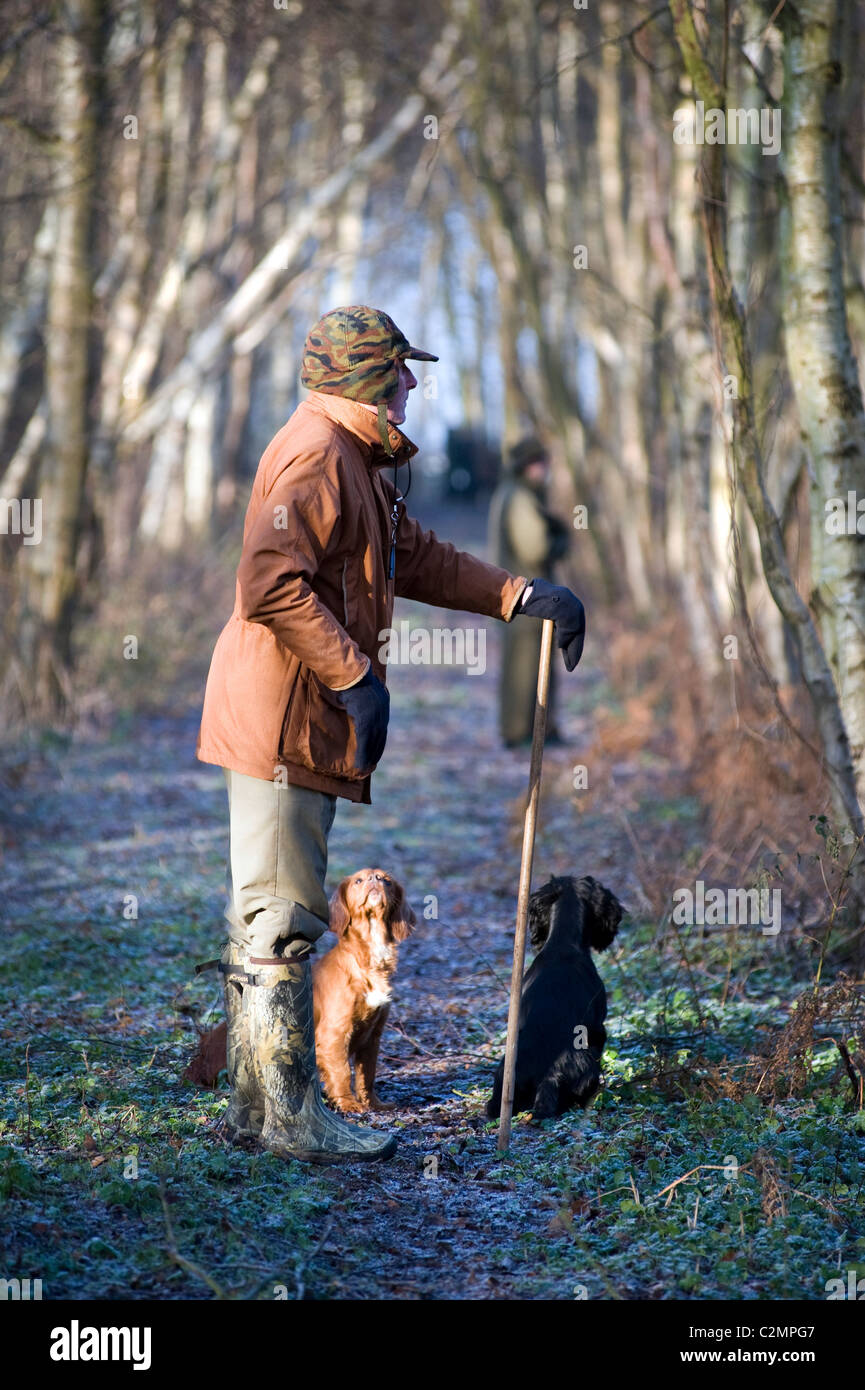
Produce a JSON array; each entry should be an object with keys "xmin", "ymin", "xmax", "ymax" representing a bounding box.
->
[{"xmin": 488, "ymin": 436, "xmax": 569, "ymax": 748}]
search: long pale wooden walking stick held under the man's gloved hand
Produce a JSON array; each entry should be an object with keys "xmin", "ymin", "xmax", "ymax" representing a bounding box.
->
[{"xmin": 498, "ymin": 619, "xmax": 553, "ymax": 1154}]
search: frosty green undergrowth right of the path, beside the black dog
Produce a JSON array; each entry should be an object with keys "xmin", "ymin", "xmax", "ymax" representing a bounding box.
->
[{"xmin": 475, "ymin": 929, "xmax": 865, "ymax": 1300}]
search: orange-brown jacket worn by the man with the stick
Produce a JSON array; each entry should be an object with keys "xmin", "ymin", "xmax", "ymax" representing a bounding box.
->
[{"xmin": 196, "ymin": 392, "xmax": 526, "ymax": 802}]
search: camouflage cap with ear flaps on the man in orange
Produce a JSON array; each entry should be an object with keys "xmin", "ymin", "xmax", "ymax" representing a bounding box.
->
[{"xmin": 300, "ymin": 304, "xmax": 438, "ymax": 404}]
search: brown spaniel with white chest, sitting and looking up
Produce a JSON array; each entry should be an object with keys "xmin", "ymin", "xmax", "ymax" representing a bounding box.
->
[{"xmin": 313, "ymin": 869, "xmax": 417, "ymax": 1111}]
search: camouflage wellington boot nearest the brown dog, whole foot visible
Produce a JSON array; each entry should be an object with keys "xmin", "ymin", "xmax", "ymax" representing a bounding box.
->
[{"xmin": 243, "ymin": 956, "xmax": 396, "ymax": 1163}]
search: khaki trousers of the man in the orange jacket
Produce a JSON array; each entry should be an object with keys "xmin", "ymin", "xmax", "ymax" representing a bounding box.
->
[{"xmin": 223, "ymin": 767, "xmax": 337, "ymax": 956}]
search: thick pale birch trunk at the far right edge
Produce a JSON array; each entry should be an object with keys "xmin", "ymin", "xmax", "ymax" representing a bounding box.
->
[{"xmin": 782, "ymin": 0, "xmax": 865, "ymax": 805}]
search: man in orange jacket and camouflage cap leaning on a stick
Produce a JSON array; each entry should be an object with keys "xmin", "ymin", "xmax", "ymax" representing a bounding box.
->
[{"xmin": 197, "ymin": 304, "xmax": 585, "ymax": 1163}]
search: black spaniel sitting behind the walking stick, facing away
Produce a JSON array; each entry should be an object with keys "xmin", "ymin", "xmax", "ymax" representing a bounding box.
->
[{"xmin": 487, "ymin": 877, "xmax": 624, "ymax": 1120}]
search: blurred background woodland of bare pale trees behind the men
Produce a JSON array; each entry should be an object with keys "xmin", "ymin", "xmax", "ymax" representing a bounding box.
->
[{"xmin": 0, "ymin": 0, "xmax": 865, "ymax": 945}]
